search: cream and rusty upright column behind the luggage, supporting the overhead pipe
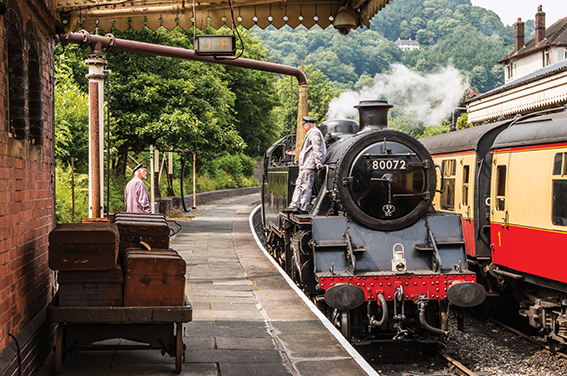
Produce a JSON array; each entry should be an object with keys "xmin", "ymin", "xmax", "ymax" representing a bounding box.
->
[{"xmin": 85, "ymin": 53, "xmax": 106, "ymax": 218}]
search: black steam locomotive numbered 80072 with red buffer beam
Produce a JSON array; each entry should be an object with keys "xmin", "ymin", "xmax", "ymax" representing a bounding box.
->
[{"xmin": 261, "ymin": 101, "xmax": 485, "ymax": 343}]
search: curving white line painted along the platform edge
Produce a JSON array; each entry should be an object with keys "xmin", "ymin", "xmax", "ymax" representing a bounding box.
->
[{"xmin": 248, "ymin": 205, "xmax": 379, "ymax": 376}]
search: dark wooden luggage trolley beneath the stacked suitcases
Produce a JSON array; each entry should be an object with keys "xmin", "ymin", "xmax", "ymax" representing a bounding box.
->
[{"xmin": 47, "ymin": 295, "xmax": 193, "ymax": 375}]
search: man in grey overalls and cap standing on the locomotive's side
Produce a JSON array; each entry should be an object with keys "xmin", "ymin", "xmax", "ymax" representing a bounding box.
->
[{"xmin": 283, "ymin": 116, "xmax": 327, "ymax": 214}]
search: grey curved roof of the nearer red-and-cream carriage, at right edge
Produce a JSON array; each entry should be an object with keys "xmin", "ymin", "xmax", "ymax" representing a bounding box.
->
[{"xmin": 492, "ymin": 109, "xmax": 567, "ymax": 149}]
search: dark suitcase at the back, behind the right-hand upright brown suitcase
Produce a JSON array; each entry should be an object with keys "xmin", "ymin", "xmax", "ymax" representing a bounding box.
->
[{"xmin": 114, "ymin": 218, "xmax": 169, "ymax": 252}]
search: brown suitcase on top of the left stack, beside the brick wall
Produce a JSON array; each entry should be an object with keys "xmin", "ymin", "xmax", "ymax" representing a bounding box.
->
[{"xmin": 49, "ymin": 222, "xmax": 120, "ymax": 270}]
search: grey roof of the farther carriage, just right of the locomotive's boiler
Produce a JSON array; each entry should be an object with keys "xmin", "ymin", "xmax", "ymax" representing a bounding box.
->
[{"xmin": 419, "ymin": 120, "xmax": 511, "ymax": 155}]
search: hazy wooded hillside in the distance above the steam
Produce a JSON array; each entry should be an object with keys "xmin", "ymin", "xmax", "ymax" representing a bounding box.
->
[{"xmin": 254, "ymin": 0, "xmax": 535, "ymax": 92}]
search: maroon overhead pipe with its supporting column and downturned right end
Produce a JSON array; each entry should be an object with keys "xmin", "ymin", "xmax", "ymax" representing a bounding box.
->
[{"xmin": 56, "ymin": 30, "xmax": 308, "ymax": 213}]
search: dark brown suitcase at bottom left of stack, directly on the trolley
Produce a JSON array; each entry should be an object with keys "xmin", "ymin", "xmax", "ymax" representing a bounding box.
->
[{"xmin": 57, "ymin": 264, "xmax": 124, "ymax": 307}]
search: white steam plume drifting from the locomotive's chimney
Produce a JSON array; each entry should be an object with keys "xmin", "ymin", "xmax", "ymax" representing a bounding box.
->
[{"xmin": 327, "ymin": 64, "xmax": 468, "ymax": 125}]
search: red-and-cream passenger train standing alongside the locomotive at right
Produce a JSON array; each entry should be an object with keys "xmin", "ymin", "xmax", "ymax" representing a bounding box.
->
[{"xmin": 420, "ymin": 107, "xmax": 567, "ymax": 349}]
